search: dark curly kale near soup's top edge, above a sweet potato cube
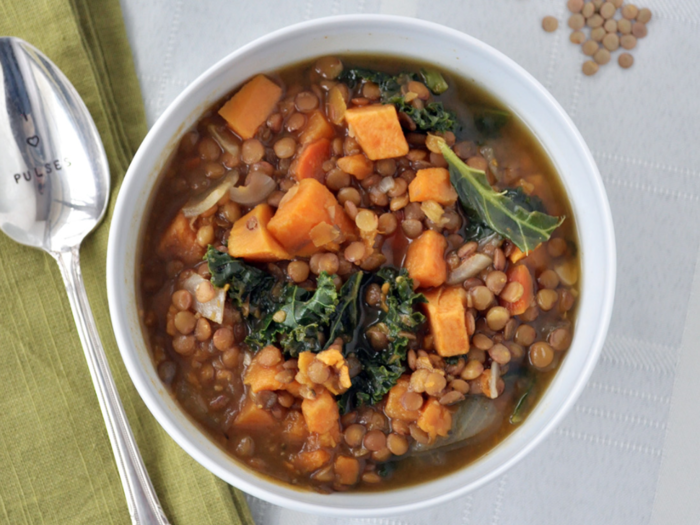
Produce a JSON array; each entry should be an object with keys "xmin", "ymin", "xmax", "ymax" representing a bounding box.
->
[{"xmin": 339, "ymin": 68, "xmax": 457, "ymax": 132}]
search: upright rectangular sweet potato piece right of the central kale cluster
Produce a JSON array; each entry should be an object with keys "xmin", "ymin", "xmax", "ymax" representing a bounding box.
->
[{"xmin": 423, "ymin": 286, "xmax": 469, "ymax": 357}]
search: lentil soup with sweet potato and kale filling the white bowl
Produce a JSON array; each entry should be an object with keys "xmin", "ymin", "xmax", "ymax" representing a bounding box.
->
[{"xmin": 139, "ymin": 56, "xmax": 579, "ymax": 492}]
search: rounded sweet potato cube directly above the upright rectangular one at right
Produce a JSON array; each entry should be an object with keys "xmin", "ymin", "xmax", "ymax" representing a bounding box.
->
[{"xmin": 404, "ymin": 230, "xmax": 447, "ymax": 288}]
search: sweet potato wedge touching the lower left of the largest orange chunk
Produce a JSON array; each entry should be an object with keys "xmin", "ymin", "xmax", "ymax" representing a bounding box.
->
[{"xmin": 228, "ymin": 204, "xmax": 292, "ymax": 262}]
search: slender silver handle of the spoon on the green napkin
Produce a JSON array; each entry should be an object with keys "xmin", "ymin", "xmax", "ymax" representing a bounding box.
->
[{"xmin": 51, "ymin": 247, "xmax": 168, "ymax": 525}]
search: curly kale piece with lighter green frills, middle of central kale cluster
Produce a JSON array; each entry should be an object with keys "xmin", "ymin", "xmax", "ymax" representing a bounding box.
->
[{"xmin": 246, "ymin": 272, "xmax": 338, "ymax": 357}]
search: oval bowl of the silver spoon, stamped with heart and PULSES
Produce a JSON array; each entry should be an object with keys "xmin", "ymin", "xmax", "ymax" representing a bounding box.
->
[{"xmin": 0, "ymin": 38, "xmax": 110, "ymax": 252}]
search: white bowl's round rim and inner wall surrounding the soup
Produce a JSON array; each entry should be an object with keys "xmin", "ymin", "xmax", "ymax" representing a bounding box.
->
[{"xmin": 107, "ymin": 15, "xmax": 615, "ymax": 517}]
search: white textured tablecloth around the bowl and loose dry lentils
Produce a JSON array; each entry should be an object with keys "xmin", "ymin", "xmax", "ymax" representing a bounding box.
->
[{"xmin": 121, "ymin": 0, "xmax": 700, "ymax": 525}]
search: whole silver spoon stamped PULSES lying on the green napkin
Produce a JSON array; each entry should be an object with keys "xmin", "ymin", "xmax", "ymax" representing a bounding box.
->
[{"xmin": 0, "ymin": 38, "xmax": 168, "ymax": 525}]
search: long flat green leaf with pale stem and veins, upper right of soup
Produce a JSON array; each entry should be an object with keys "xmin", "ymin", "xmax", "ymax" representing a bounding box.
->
[{"xmin": 439, "ymin": 140, "xmax": 564, "ymax": 253}]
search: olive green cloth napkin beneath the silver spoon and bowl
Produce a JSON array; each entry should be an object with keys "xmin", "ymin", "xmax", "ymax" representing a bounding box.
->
[{"xmin": 0, "ymin": 0, "xmax": 253, "ymax": 525}]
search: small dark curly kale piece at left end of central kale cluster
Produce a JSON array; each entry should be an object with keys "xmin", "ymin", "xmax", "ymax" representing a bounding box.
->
[{"xmin": 204, "ymin": 246, "xmax": 275, "ymax": 307}]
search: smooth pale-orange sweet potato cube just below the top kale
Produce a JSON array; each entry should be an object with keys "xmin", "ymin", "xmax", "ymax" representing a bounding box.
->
[{"xmin": 345, "ymin": 104, "xmax": 408, "ymax": 160}]
